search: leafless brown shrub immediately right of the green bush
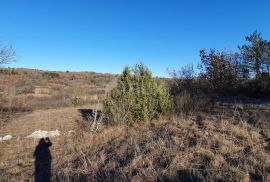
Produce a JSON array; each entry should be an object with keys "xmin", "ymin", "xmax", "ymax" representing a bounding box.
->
[{"xmin": 168, "ymin": 65, "xmax": 211, "ymax": 115}]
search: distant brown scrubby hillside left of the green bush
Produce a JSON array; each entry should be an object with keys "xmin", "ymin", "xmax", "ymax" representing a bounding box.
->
[{"xmin": 0, "ymin": 69, "xmax": 116, "ymax": 113}]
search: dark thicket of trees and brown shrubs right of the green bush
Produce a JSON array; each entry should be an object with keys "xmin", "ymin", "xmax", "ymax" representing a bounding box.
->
[{"xmin": 169, "ymin": 31, "xmax": 270, "ymax": 114}]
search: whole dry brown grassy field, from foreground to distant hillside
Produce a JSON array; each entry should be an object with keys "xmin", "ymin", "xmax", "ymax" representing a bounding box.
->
[{"xmin": 0, "ymin": 69, "xmax": 270, "ymax": 181}]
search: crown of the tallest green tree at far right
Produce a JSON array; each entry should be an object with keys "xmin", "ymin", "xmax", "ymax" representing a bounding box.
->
[{"xmin": 239, "ymin": 31, "xmax": 266, "ymax": 79}]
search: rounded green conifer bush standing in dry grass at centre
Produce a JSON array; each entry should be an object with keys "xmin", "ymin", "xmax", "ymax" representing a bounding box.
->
[{"xmin": 104, "ymin": 63, "xmax": 171, "ymax": 124}]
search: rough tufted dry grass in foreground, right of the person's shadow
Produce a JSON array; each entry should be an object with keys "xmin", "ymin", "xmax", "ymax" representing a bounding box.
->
[{"xmin": 57, "ymin": 118, "xmax": 270, "ymax": 181}]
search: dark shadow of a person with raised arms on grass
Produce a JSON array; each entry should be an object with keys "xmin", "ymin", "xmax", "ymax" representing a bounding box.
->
[{"xmin": 34, "ymin": 138, "xmax": 52, "ymax": 182}]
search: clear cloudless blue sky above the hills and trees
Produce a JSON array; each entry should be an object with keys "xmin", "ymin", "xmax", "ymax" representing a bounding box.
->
[{"xmin": 0, "ymin": 0, "xmax": 270, "ymax": 76}]
